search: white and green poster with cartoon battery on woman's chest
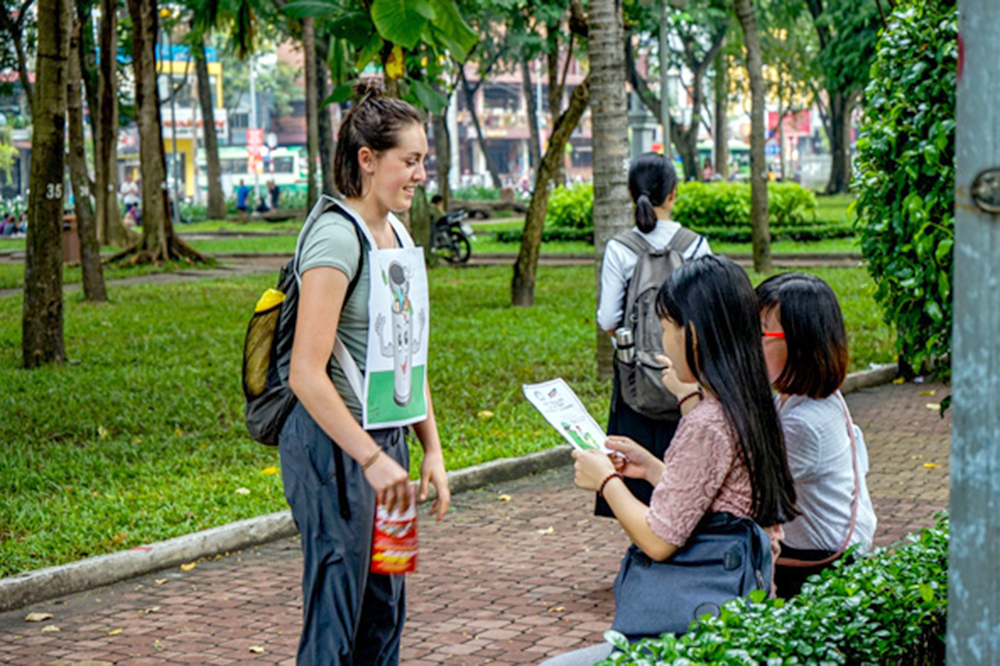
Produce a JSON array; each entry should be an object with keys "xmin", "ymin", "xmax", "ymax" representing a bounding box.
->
[{"xmin": 364, "ymin": 248, "xmax": 429, "ymax": 430}]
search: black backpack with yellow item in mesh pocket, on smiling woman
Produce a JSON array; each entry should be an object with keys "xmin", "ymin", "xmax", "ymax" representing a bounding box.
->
[{"xmin": 243, "ymin": 199, "xmax": 365, "ymax": 446}]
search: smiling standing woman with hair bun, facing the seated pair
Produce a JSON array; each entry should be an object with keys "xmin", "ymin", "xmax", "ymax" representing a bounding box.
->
[{"xmin": 279, "ymin": 88, "xmax": 450, "ymax": 666}]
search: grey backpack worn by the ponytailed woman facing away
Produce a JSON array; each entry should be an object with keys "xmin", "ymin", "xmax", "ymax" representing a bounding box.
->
[{"xmin": 614, "ymin": 227, "xmax": 704, "ymax": 420}]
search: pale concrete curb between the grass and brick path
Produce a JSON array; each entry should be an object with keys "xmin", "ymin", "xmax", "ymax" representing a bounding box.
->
[{"xmin": 0, "ymin": 364, "xmax": 898, "ymax": 613}]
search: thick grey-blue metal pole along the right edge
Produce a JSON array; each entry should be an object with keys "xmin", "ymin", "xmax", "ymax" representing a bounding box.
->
[{"xmin": 947, "ymin": 0, "xmax": 1000, "ymax": 665}]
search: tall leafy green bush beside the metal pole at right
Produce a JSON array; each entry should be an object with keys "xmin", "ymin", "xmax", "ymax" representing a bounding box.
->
[{"xmin": 854, "ymin": 0, "xmax": 958, "ymax": 375}]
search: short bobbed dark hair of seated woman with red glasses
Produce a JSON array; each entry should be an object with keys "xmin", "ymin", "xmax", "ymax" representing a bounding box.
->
[{"xmin": 757, "ymin": 273, "xmax": 850, "ymax": 398}]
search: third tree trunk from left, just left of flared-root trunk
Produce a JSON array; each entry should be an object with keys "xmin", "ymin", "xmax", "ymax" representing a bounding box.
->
[{"xmin": 90, "ymin": 0, "xmax": 129, "ymax": 247}]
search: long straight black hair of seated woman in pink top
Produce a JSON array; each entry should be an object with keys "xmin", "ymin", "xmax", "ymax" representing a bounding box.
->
[{"xmin": 656, "ymin": 255, "xmax": 797, "ymax": 527}]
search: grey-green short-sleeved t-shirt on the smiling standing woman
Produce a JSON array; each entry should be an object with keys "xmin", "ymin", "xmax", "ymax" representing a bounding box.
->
[{"xmin": 299, "ymin": 212, "xmax": 370, "ymax": 423}]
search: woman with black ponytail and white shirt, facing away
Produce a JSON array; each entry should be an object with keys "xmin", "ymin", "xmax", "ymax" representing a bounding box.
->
[{"xmin": 595, "ymin": 153, "xmax": 712, "ymax": 516}]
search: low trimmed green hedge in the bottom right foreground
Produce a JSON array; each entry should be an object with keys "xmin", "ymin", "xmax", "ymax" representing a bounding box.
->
[{"xmin": 602, "ymin": 519, "xmax": 948, "ymax": 666}]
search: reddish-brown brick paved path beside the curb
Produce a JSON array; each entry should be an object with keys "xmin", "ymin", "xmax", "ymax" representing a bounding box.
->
[{"xmin": 0, "ymin": 384, "xmax": 950, "ymax": 666}]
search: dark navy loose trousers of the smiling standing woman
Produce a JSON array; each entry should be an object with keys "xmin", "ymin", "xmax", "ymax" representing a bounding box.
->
[{"xmin": 278, "ymin": 404, "xmax": 410, "ymax": 666}]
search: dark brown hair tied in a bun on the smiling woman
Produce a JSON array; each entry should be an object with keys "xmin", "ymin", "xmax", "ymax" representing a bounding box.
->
[{"xmin": 333, "ymin": 83, "xmax": 424, "ymax": 197}]
